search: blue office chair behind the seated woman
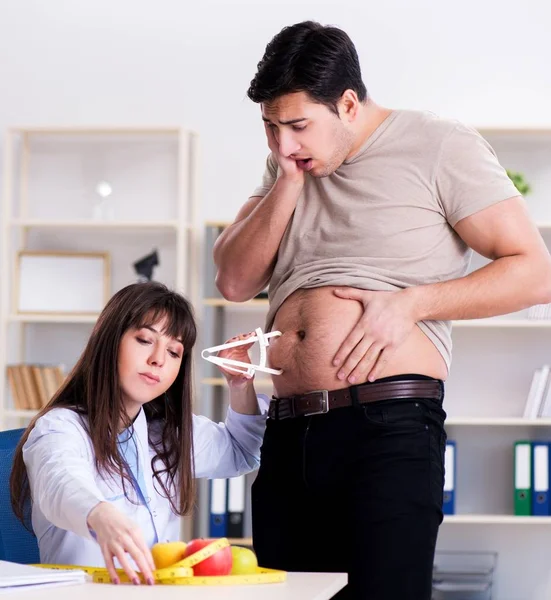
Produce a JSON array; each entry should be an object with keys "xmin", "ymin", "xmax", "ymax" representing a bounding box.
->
[{"xmin": 0, "ymin": 429, "xmax": 40, "ymax": 564}]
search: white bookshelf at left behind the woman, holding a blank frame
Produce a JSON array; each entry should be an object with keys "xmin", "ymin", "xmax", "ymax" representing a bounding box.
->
[{"xmin": 0, "ymin": 126, "xmax": 199, "ymax": 428}]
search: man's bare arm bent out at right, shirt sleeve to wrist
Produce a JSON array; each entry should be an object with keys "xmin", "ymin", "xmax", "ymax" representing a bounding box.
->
[{"xmin": 405, "ymin": 196, "xmax": 551, "ymax": 321}]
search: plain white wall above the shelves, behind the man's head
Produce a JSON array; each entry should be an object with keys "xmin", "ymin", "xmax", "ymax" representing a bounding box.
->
[{"xmin": 0, "ymin": 0, "xmax": 551, "ymax": 219}]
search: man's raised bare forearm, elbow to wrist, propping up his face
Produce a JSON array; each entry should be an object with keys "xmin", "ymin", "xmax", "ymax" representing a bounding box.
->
[{"xmin": 214, "ymin": 177, "xmax": 304, "ymax": 302}]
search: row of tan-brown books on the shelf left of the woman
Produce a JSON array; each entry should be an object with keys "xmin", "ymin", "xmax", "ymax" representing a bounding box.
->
[{"xmin": 6, "ymin": 364, "xmax": 65, "ymax": 410}]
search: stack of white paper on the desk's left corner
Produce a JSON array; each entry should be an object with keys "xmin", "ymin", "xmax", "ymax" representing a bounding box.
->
[{"xmin": 0, "ymin": 560, "xmax": 86, "ymax": 594}]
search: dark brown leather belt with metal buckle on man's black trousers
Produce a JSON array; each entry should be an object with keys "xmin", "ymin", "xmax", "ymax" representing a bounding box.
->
[{"xmin": 268, "ymin": 379, "xmax": 443, "ymax": 420}]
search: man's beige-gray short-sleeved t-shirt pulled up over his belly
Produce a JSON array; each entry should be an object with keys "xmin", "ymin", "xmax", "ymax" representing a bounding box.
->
[{"xmin": 251, "ymin": 110, "xmax": 519, "ymax": 369}]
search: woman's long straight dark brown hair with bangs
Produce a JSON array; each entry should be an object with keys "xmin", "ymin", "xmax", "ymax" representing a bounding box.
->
[{"xmin": 10, "ymin": 282, "xmax": 197, "ymax": 526}]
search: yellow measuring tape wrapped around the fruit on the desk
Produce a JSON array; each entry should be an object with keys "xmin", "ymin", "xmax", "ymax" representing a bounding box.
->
[{"xmin": 34, "ymin": 538, "xmax": 287, "ymax": 585}]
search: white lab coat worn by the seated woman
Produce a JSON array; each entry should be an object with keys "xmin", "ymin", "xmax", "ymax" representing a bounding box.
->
[{"xmin": 23, "ymin": 397, "xmax": 267, "ymax": 566}]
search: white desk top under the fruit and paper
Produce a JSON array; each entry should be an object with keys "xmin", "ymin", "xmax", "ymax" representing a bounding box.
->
[{"xmin": 9, "ymin": 573, "xmax": 348, "ymax": 600}]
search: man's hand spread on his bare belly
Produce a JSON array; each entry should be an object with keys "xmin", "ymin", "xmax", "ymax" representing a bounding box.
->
[{"xmin": 333, "ymin": 288, "xmax": 417, "ymax": 384}]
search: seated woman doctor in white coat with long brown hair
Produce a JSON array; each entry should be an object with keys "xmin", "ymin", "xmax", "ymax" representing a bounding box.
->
[{"xmin": 10, "ymin": 282, "xmax": 265, "ymax": 584}]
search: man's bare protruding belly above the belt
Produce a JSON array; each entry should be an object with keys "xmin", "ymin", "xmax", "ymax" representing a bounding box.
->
[{"xmin": 268, "ymin": 287, "xmax": 448, "ymax": 397}]
